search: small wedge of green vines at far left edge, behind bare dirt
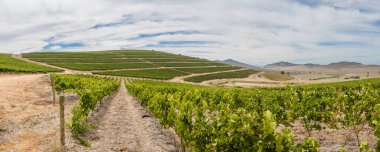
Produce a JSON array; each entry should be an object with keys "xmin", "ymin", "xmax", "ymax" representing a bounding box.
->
[{"xmin": 0, "ymin": 54, "xmax": 63, "ymax": 73}]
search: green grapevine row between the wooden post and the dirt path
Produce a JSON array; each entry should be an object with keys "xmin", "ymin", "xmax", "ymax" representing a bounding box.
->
[{"xmin": 52, "ymin": 75, "xmax": 120, "ymax": 146}]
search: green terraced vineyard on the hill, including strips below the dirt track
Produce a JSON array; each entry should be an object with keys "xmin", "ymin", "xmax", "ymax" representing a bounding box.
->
[{"xmin": 23, "ymin": 50, "xmax": 255, "ymax": 82}]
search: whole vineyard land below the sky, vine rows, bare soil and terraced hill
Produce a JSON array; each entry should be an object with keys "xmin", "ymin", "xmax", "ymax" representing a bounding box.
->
[{"xmin": 0, "ymin": 50, "xmax": 380, "ymax": 152}]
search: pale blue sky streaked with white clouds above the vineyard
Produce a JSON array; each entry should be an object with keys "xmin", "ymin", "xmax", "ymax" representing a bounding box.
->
[{"xmin": 0, "ymin": 0, "xmax": 380, "ymax": 65}]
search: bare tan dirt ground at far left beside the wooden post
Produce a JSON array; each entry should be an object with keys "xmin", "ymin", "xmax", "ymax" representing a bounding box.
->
[{"xmin": 0, "ymin": 74, "xmax": 59, "ymax": 152}]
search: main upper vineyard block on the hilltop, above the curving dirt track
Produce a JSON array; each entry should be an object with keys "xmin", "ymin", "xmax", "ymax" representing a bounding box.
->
[{"xmin": 23, "ymin": 50, "xmax": 227, "ymax": 71}]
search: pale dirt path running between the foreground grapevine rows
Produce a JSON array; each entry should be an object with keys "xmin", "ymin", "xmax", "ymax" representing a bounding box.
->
[{"xmin": 68, "ymin": 84, "xmax": 176, "ymax": 152}]
